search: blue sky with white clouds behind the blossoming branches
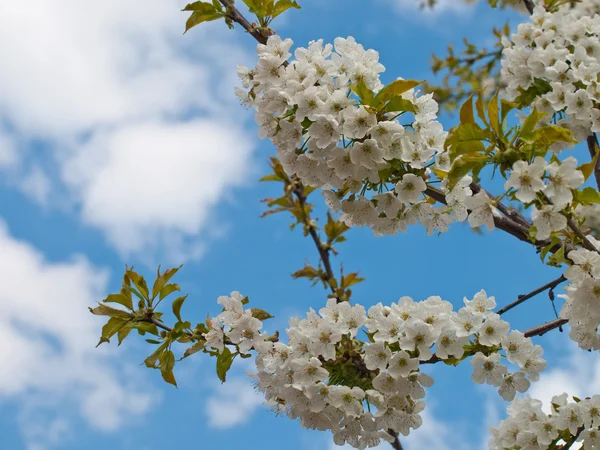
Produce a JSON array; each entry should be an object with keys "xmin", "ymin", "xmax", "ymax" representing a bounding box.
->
[{"xmin": 0, "ymin": 0, "xmax": 600, "ymax": 450}]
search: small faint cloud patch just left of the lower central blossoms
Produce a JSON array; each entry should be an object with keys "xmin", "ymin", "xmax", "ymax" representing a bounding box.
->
[{"xmin": 205, "ymin": 376, "xmax": 264, "ymax": 429}]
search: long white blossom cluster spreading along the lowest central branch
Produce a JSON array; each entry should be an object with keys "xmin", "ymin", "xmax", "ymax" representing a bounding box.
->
[{"xmin": 206, "ymin": 291, "xmax": 546, "ymax": 449}]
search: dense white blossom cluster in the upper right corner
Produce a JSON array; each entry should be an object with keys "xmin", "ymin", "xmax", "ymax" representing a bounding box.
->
[{"xmin": 501, "ymin": 2, "xmax": 600, "ymax": 142}]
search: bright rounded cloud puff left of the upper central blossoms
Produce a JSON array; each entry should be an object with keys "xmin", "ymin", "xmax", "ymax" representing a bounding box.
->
[{"xmin": 64, "ymin": 119, "xmax": 252, "ymax": 262}]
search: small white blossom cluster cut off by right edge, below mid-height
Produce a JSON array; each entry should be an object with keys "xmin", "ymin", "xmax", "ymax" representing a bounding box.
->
[{"xmin": 560, "ymin": 236, "xmax": 600, "ymax": 350}]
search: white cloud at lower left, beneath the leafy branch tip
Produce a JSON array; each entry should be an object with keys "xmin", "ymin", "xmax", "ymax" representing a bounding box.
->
[{"xmin": 0, "ymin": 218, "xmax": 157, "ymax": 449}]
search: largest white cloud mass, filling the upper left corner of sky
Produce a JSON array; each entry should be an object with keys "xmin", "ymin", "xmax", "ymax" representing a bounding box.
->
[{"xmin": 0, "ymin": 0, "xmax": 255, "ymax": 262}]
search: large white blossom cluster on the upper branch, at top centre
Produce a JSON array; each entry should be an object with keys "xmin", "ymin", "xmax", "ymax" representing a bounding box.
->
[{"xmin": 237, "ymin": 36, "xmax": 493, "ymax": 235}]
